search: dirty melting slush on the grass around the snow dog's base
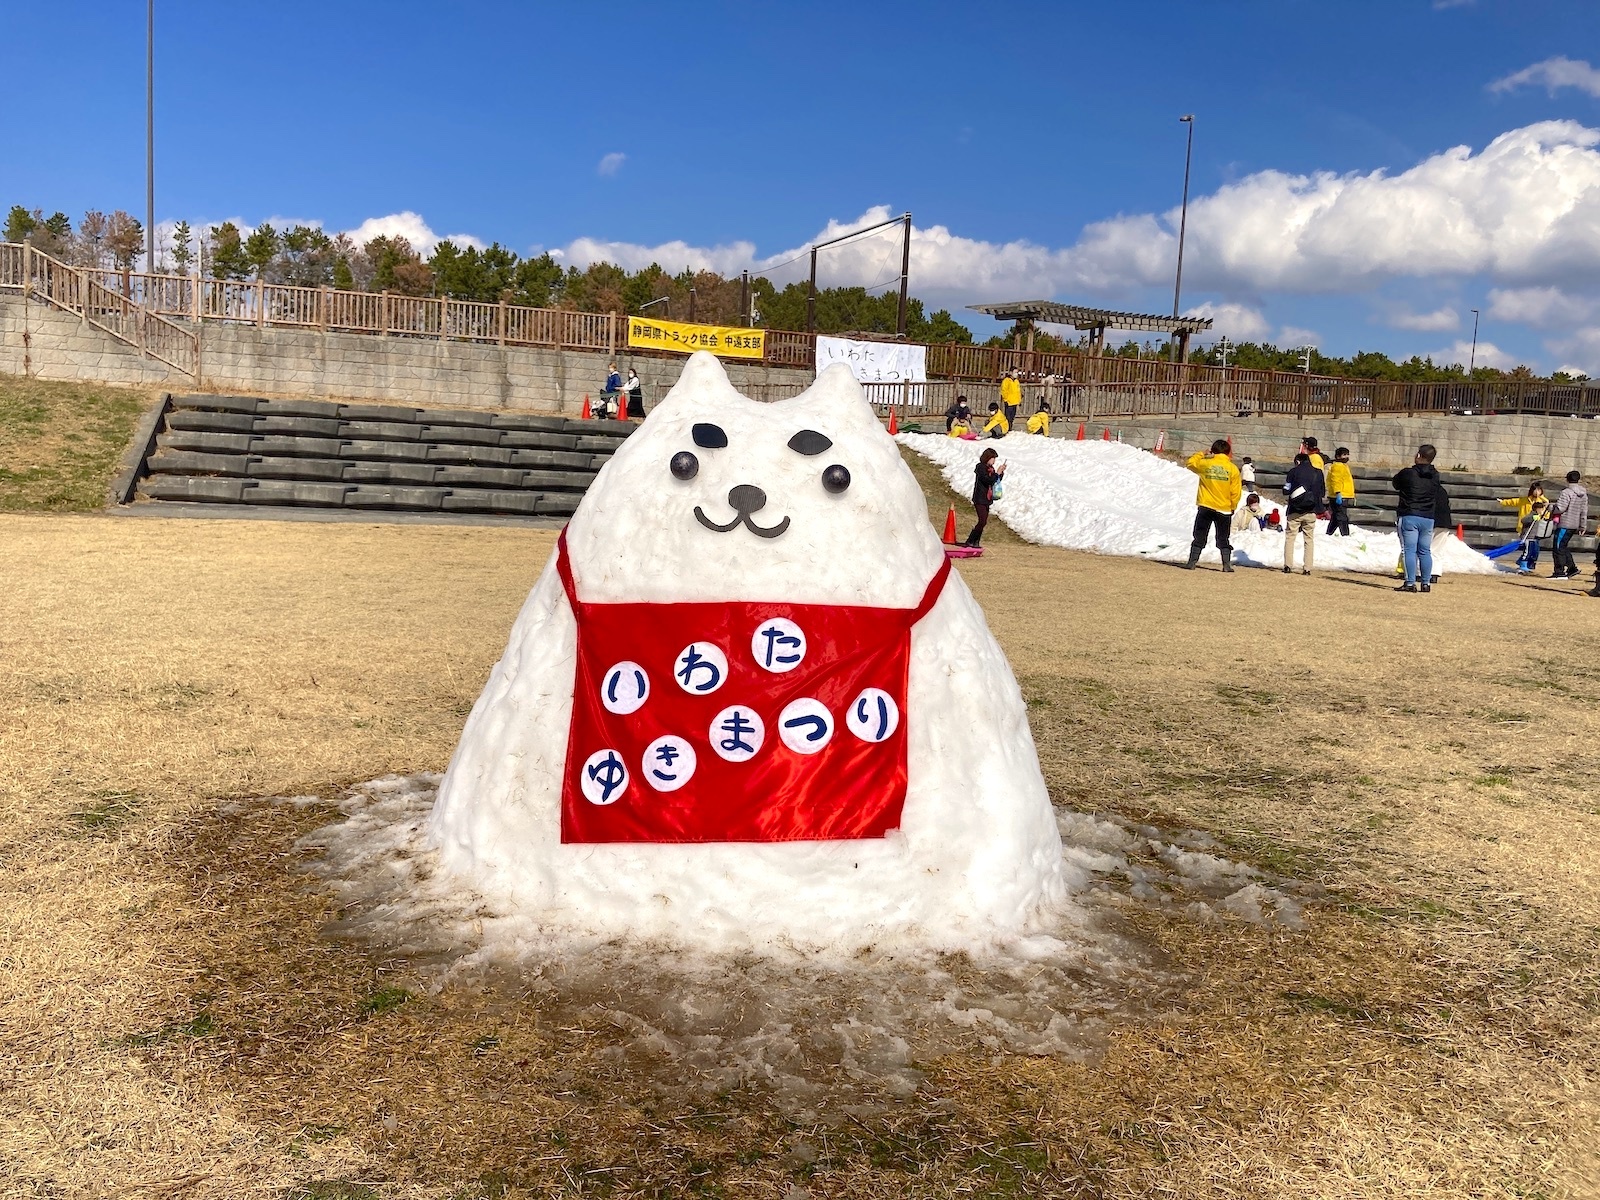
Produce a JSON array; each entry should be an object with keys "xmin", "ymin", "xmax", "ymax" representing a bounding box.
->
[{"xmin": 283, "ymin": 774, "xmax": 1302, "ymax": 1115}]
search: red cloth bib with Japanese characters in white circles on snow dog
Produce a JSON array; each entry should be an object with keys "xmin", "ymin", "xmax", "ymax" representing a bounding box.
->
[{"xmin": 557, "ymin": 533, "xmax": 950, "ymax": 842}]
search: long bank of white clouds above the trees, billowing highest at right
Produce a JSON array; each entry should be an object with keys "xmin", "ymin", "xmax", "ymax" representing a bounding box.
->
[{"xmin": 565, "ymin": 122, "xmax": 1600, "ymax": 304}]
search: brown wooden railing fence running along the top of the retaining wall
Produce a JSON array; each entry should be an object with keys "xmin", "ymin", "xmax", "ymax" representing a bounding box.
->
[{"xmin": 0, "ymin": 243, "xmax": 1600, "ymax": 421}]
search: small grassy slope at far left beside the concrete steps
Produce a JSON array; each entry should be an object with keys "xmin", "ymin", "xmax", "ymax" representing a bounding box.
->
[{"xmin": 0, "ymin": 374, "xmax": 152, "ymax": 512}]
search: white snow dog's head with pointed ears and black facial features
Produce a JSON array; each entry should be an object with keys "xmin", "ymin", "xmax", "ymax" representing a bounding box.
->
[{"xmin": 566, "ymin": 352, "xmax": 942, "ymax": 608}]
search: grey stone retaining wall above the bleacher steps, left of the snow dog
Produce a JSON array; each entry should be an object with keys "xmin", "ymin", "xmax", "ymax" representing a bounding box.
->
[{"xmin": 0, "ymin": 296, "xmax": 811, "ymax": 416}]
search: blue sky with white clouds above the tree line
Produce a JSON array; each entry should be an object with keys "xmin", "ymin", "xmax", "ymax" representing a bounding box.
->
[{"xmin": 9, "ymin": 0, "xmax": 1600, "ymax": 374}]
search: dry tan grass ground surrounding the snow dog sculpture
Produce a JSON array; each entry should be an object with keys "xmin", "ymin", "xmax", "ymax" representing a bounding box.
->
[{"xmin": 0, "ymin": 499, "xmax": 1600, "ymax": 1200}]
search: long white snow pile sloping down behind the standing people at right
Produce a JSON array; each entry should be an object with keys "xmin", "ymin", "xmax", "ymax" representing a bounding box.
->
[{"xmin": 899, "ymin": 434, "xmax": 1499, "ymax": 574}]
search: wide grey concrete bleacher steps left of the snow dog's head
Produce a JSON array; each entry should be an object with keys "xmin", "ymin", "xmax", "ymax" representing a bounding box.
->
[{"xmin": 136, "ymin": 395, "xmax": 634, "ymax": 517}]
